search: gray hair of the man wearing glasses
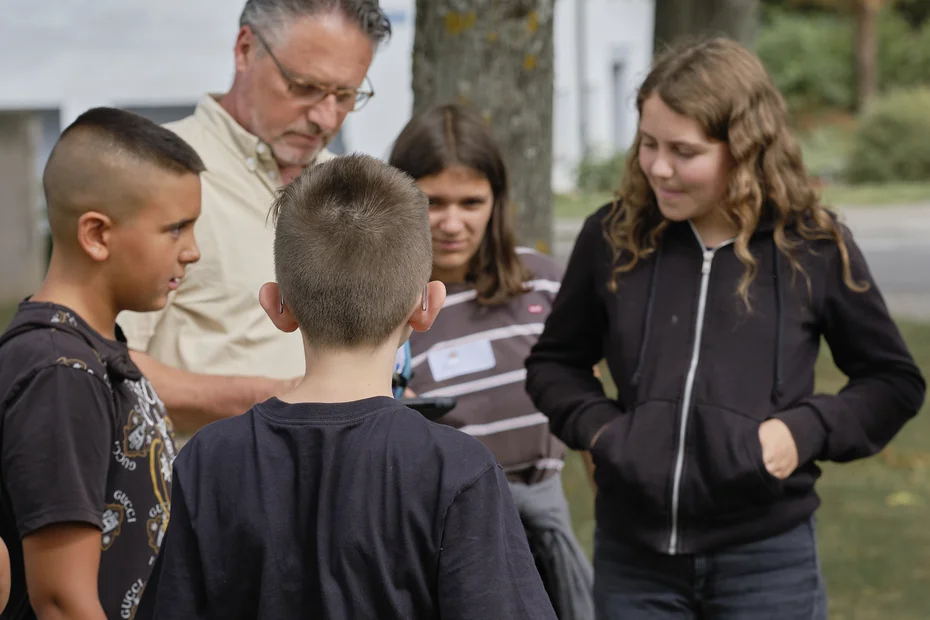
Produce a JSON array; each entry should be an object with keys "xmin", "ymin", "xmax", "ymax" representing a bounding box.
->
[{"xmin": 239, "ymin": 0, "xmax": 391, "ymax": 48}]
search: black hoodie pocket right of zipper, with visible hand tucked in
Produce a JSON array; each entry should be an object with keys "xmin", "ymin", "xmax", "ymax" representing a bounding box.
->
[{"xmin": 681, "ymin": 405, "xmax": 782, "ymax": 519}]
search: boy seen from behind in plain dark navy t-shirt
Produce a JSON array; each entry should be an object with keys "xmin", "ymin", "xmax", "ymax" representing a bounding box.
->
[{"xmin": 136, "ymin": 155, "xmax": 555, "ymax": 620}]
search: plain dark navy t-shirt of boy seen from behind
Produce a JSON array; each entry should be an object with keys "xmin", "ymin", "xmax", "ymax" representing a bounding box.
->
[{"xmin": 137, "ymin": 397, "xmax": 555, "ymax": 620}]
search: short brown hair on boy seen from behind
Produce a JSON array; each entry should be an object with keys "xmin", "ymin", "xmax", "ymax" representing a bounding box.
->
[{"xmin": 271, "ymin": 155, "xmax": 433, "ymax": 348}]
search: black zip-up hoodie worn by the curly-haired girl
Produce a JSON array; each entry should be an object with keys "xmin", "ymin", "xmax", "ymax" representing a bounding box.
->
[{"xmin": 526, "ymin": 205, "xmax": 925, "ymax": 554}]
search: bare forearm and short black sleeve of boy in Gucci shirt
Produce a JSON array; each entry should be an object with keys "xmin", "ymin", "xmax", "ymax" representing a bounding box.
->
[{"xmin": 0, "ymin": 364, "xmax": 114, "ymax": 620}]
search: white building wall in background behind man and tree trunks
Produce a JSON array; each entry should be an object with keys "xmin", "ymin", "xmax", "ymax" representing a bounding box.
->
[{"xmin": 0, "ymin": 0, "xmax": 653, "ymax": 190}]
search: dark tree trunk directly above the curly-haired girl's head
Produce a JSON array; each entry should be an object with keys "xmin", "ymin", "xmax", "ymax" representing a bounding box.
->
[{"xmin": 653, "ymin": 0, "xmax": 759, "ymax": 52}]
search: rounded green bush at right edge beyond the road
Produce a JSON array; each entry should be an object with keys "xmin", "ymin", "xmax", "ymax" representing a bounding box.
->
[{"xmin": 847, "ymin": 87, "xmax": 930, "ymax": 183}]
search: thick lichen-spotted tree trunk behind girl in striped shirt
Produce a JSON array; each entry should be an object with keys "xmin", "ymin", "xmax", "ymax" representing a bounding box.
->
[{"xmin": 413, "ymin": 0, "xmax": 555, "ymax": 252}]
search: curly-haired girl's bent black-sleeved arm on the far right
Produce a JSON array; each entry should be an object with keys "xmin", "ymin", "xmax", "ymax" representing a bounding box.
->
[{"xmin": 775, "ymin": 230, "xmax": 925, "ymax": 465}]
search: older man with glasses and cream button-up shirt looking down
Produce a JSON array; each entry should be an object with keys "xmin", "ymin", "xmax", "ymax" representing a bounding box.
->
[{"xmin": 119, "ymin": 0, "xmax": 391, "ymax": 433}]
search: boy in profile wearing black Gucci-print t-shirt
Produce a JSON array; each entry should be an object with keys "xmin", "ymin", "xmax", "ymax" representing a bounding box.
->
[{"xmin": 0, "ymin": 108, "xmax": 204, "ymax": 620}]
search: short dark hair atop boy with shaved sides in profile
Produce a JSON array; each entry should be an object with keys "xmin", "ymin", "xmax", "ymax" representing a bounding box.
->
[{"xmin": 57, "ymin": 107, "xmax": 206, "ymax": 174}]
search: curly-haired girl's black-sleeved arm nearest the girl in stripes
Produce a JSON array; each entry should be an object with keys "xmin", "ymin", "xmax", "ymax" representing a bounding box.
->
[{"xmin": 526, "ymin": 215, "xmax": 620, "ymax": 450}]
